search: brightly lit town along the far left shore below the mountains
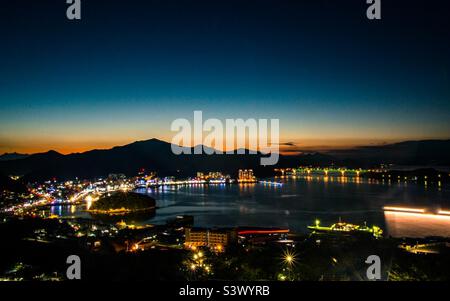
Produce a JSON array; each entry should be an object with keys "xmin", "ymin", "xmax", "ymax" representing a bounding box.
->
[{"xmin": 0, "ymin": 169, "xmax": 264, "ymax": 224}]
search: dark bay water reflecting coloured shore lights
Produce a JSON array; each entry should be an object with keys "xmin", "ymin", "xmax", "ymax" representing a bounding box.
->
[{"xmin": 45, "ymin": 176, "xmax": 450, "ymax": 236}]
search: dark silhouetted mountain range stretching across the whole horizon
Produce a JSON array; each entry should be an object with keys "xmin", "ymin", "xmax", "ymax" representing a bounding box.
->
[{"xmin": 0, "ymin": 139, "xmax": 450, "ymax": 181}]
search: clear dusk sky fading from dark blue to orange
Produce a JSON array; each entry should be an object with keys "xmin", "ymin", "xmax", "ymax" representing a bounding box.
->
[{"xmin": 0, "ymin": 0, "xmax": 450, "ymax": 153}]
